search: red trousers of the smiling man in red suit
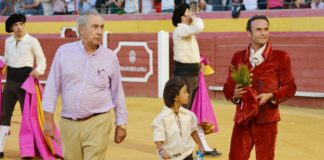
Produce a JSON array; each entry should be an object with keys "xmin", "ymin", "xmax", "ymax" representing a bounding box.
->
[{"xmin": 229, "ymin": 119, "xmax": 278, "ymax": 160}]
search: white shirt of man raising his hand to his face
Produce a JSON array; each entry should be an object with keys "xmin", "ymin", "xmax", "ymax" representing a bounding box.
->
[{"xmin": 173, "ymin": 16, "xmax": 204, "ymax": 63}]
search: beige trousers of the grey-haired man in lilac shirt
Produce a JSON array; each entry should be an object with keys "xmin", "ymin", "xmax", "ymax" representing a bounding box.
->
[{"xmin": 60, "ymin": 112, "xmax": 112, "ymax": 160}]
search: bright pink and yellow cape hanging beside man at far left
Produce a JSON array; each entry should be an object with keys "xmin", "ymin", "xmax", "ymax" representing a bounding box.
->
[{"xmin": 19, "ymin": 77, "xmax": 63, "ymax": 160}]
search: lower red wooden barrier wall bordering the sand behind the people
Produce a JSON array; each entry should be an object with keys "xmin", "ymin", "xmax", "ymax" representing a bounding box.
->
[{"xmin": 0, "ymin": 34, "xmax": 324, "ymax": 108}]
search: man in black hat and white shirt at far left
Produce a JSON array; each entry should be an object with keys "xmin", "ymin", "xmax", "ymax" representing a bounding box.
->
[{"xmin": 0, "ymin": 14, "xmax": 46, "ymax": 158}]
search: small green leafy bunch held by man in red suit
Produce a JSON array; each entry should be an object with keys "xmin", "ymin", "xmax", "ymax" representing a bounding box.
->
[{"xmin": 231, "ymin": 64, "xmax": 251, "ymax": 88}]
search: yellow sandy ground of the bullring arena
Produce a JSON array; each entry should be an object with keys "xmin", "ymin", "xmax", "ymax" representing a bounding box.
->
[{"xmin": 5, "ymin": 97, "xmax": 324, "ymax": 160}]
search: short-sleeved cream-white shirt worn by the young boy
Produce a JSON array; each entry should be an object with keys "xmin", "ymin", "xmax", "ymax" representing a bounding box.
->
[{"xmin": 152, "ymin": 106, "xmax": 198, "ymax": 160}]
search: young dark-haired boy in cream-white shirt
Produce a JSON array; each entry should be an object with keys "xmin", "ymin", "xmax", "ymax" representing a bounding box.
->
[{"xmin": 152, "ymin": 78, "xmax": 203, "ymax": 160}]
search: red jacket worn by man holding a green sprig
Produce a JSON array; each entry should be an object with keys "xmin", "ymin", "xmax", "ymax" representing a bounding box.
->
[{"xmin": 223, "ymin": 43, "xmax": 296, "ymax": 124}]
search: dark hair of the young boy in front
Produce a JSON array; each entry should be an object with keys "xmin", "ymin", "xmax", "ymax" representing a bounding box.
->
[{"xmin": 163, "ymin": 77, "xmax": 186, "ymax": 108}]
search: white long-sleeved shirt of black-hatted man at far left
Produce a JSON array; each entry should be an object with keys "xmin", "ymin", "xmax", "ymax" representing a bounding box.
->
[{"xmin": 4, "ymin": 33, "xmax": 46, "ymax": 74}]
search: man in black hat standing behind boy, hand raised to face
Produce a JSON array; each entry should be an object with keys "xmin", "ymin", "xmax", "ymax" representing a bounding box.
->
[{"xmin": 172, "ymin": 4, "xmax": 220, "ymax": 156}]
